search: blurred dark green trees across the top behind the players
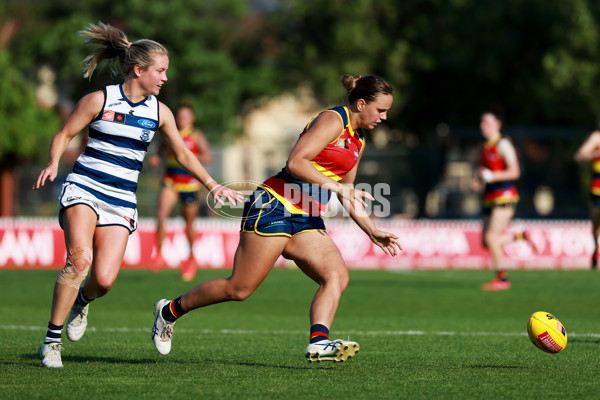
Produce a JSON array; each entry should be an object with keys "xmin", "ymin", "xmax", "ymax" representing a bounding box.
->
[{"xmin": 0, "ymin": 0, "xmax": 600, "ymax": 216}]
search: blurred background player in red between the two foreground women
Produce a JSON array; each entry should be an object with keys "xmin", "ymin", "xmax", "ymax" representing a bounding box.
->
[{"xmin": 149, "ymin": 101, "xmax": 212, "ymax": 281}]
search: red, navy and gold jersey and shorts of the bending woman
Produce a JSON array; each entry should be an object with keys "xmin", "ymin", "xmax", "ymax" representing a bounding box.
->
[{"xmin": 241, "ymin": 106, "xmax": 364, "ymax": 236}]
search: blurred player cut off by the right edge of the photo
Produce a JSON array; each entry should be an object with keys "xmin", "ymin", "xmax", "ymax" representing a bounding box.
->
[{"xmin": 575, "ymin": 131, "xmax": 600, "ymax": 269}]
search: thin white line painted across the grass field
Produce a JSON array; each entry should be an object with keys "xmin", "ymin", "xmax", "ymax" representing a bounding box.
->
[{"xmin": 0, "ymin": 325, "xmax": 600, "ymax": 338}]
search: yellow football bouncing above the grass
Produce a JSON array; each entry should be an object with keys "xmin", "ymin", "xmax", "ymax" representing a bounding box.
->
[{"xmin": 527, "ymin": 311, "xmax": 567, "ymax": 353}]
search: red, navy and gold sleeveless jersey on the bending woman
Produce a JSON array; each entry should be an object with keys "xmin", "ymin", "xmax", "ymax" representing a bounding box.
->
[{"xmin": 262, "ymin": 107, "xmax": 364, "ymax": 215}]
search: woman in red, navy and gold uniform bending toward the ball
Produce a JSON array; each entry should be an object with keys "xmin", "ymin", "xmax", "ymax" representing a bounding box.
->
[{"xmin": 152, "ymin": 75, "xmax": 401, "ymax": 361}]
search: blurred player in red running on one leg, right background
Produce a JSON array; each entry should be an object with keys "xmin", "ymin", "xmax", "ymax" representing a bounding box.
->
[{"xmin": 471, "ymin": 112, "xmax": 537, "ymax": 290}]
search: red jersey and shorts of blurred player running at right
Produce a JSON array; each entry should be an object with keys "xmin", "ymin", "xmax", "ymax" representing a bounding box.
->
[{"xmin": 480, "ymin": 135, "xmax": 519, "ymax": 207}]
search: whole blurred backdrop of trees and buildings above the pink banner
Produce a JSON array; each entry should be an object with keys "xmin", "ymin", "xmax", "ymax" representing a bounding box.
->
[{"xmin": 0, "ymin": 0, "xmax": 600, "ymax": 267}]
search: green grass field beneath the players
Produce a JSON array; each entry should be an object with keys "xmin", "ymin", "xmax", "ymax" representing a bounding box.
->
[{"xmin": 0, "ymin": 269, "xmax": 600, "ymax": 400}]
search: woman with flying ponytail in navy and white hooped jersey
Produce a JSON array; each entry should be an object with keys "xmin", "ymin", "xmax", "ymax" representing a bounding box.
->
[{"xmin": 33, "ymin": 23, "xmax": 241, "ymax": 368}]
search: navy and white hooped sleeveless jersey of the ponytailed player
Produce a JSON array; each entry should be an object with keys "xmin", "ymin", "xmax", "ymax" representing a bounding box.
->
[{"xmin": 66, "ymin": 85, "xmax": 159, "ymax": 208}]
